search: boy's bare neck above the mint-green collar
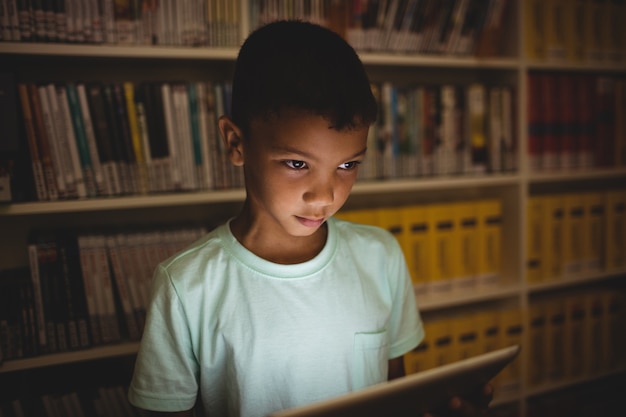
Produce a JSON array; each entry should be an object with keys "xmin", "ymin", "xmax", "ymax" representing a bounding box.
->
[{"xmin": 230, "ymin": 210, "xmax": 328, "ymax": 265}]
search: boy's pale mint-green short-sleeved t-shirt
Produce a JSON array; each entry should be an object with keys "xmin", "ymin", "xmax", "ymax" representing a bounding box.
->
[{"xmin": 129, "ymin": 218, "xmax": 423, "ymax": 417}]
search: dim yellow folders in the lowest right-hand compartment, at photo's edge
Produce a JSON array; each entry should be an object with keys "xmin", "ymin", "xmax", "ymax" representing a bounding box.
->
[{"xmin": 527, "ymin": 289, "xmax": 626, "ymax": 387}]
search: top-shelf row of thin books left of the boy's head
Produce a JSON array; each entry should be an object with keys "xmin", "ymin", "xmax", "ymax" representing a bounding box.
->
[{"xmin": 0, "ymin": 0, "xmax": 241, "ymax": 47}]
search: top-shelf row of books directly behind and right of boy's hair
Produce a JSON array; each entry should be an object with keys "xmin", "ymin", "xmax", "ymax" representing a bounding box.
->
[{"xmin": 250, "ymin": 0, "xmax": 512, "ymax": 56}]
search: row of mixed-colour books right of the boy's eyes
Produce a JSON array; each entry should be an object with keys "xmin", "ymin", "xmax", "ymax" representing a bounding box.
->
[{"xmin": 359, "ymin": 82, "xmax": 517, "ymax": 179}]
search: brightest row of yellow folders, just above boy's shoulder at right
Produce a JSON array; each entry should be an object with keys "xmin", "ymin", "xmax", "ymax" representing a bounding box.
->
[{"xmin": 337, "ymin": 199, "xmax": 502, "ymax": 296}]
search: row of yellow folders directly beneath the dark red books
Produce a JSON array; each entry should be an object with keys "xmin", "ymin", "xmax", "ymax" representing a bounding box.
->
[{"xmin": 526, "ymin": 189, "xmax": 626, "ymax": 283}]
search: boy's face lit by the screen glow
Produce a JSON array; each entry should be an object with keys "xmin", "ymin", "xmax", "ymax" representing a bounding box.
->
[{"xmin": 242, "ymin": 111, "xmax": 368, "ymax": 237}]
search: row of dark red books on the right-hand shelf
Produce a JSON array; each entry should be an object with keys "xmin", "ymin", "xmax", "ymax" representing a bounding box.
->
[{"xmin": 527, "ymin": 71, "xmax": 626, "ymax": 172}]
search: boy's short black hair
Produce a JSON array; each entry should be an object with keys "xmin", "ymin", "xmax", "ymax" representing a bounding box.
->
[{"xmin": 231, "ymin": 20, "xmax": 377, "ymax": 134}]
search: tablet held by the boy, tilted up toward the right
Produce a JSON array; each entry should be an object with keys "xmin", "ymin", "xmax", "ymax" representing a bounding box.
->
[{"xmin": 269, "ymin": 345, "xmax": 520, "ymax": 417}]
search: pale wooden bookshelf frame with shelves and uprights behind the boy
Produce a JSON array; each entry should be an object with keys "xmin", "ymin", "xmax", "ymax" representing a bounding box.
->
[{"xmin": 0, "ymin": 0, "xmax": 626, "ymax": 416}]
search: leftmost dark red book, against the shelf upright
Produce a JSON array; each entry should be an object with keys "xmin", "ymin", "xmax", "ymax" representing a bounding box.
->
[{"xmin": 527, "ymin": 72, "xmax": 544, "ymax": 172}]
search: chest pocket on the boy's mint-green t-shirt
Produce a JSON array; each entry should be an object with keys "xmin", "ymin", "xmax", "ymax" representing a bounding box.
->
[{"xmin": 353, "ymin": 329, "xmax": 389, "ymax": 390}]
